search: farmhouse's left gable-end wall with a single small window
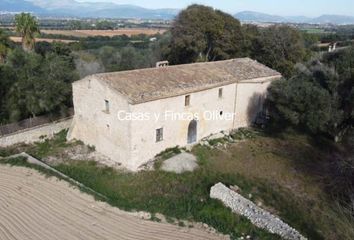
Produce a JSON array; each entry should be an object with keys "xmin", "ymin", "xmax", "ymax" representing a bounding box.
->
[{"xmin": 68, "ymin": 77, "xmax": 131, "ymax": 168}]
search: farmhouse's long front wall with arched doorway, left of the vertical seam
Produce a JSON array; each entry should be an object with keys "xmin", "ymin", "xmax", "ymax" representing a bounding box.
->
[{"xmin": 131, "ymin": 84, "xmax": 236, "ymax": 167}]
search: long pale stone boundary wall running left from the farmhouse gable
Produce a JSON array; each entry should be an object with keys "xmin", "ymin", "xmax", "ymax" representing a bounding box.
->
[{"xmin": 0, "ymin": 118, "xmax": 72, "ymax": 147}]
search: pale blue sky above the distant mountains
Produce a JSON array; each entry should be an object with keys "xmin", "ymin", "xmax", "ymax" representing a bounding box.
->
[{"xmin": 78, "ymin": 0, "xmax": 354, "ymax": 17}]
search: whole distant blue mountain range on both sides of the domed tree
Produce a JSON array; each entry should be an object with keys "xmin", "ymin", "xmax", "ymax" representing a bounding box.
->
[{"xmin": 0, "ymin": 0, "xmax": 354, "ymax": 25}]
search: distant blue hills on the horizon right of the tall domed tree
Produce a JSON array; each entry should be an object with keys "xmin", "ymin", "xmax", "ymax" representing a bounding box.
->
[{"xmin": 234, "ymin": 11, "xmax": 354, "ymax": 24}]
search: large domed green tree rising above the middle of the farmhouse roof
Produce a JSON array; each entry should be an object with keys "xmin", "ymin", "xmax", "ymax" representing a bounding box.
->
[{"xmin": 169, "ymin": 5, "xmax": 243, "ymax": 64}]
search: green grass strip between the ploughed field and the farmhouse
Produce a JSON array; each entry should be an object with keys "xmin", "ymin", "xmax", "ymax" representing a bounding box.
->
[{"xmin": 56, "ymin": 162, "xmax": 277, "ymax": 239}]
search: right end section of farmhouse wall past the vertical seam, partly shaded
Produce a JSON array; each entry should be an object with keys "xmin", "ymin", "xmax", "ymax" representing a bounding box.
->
[{"xmin": 234, "ymin": 81, "xmax": 271, "ymax": 129}]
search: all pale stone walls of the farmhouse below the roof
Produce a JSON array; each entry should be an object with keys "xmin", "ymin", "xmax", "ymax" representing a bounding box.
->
[{"xmin": 68, "ymin": 77, "xmax": 278, "ymax": 170}]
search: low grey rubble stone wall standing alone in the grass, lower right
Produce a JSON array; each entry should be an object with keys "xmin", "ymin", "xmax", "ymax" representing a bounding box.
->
[{"xmin": 210, "ymin": 183, "xmax": 306, "ymax": 240}]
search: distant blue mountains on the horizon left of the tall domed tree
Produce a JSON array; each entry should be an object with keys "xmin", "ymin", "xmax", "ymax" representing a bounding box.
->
[{"xmin": 0, "ymin": 0, "xmax": 179, "ymax": 19}]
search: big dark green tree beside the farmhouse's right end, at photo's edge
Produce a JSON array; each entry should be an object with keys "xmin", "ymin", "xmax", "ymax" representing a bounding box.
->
[{"xmin": 268, "ymin": 52, "xmax": 354, "ymax": 141}]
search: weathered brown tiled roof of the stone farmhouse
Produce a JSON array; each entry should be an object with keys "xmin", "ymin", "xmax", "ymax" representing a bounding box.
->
[{"xmin": 91, "ymin": 58, "xmax": 281, "ymax": 104}]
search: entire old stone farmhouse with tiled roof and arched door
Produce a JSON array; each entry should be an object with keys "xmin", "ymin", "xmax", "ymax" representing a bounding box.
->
[{"xmin": 68, "ymin": 58, "xmax": 281, "ymax": 171}]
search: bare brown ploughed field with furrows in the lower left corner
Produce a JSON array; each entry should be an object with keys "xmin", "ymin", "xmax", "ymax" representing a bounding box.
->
[{"xmin": 0, "ymin": 165, "xmax": 227, "ymax": 240}]
